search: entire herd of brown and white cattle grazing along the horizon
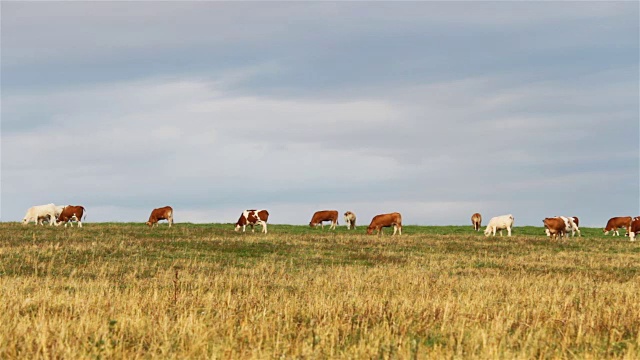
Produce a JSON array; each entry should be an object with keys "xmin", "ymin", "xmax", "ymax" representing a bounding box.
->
[{"xmin": 17, "ymin": 204, "xmax": 640, "ymax": 241}]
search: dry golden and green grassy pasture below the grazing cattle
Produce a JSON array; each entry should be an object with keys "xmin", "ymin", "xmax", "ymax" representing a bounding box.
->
[{"xmin": 0, "ymin": 223, "xmax": 640, "ymax": 359}]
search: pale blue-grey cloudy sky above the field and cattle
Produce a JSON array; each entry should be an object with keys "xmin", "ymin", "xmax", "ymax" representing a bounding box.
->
[{"xmin": 0, "ymin": 1, "xmax": 640, "ymax": 227}]
